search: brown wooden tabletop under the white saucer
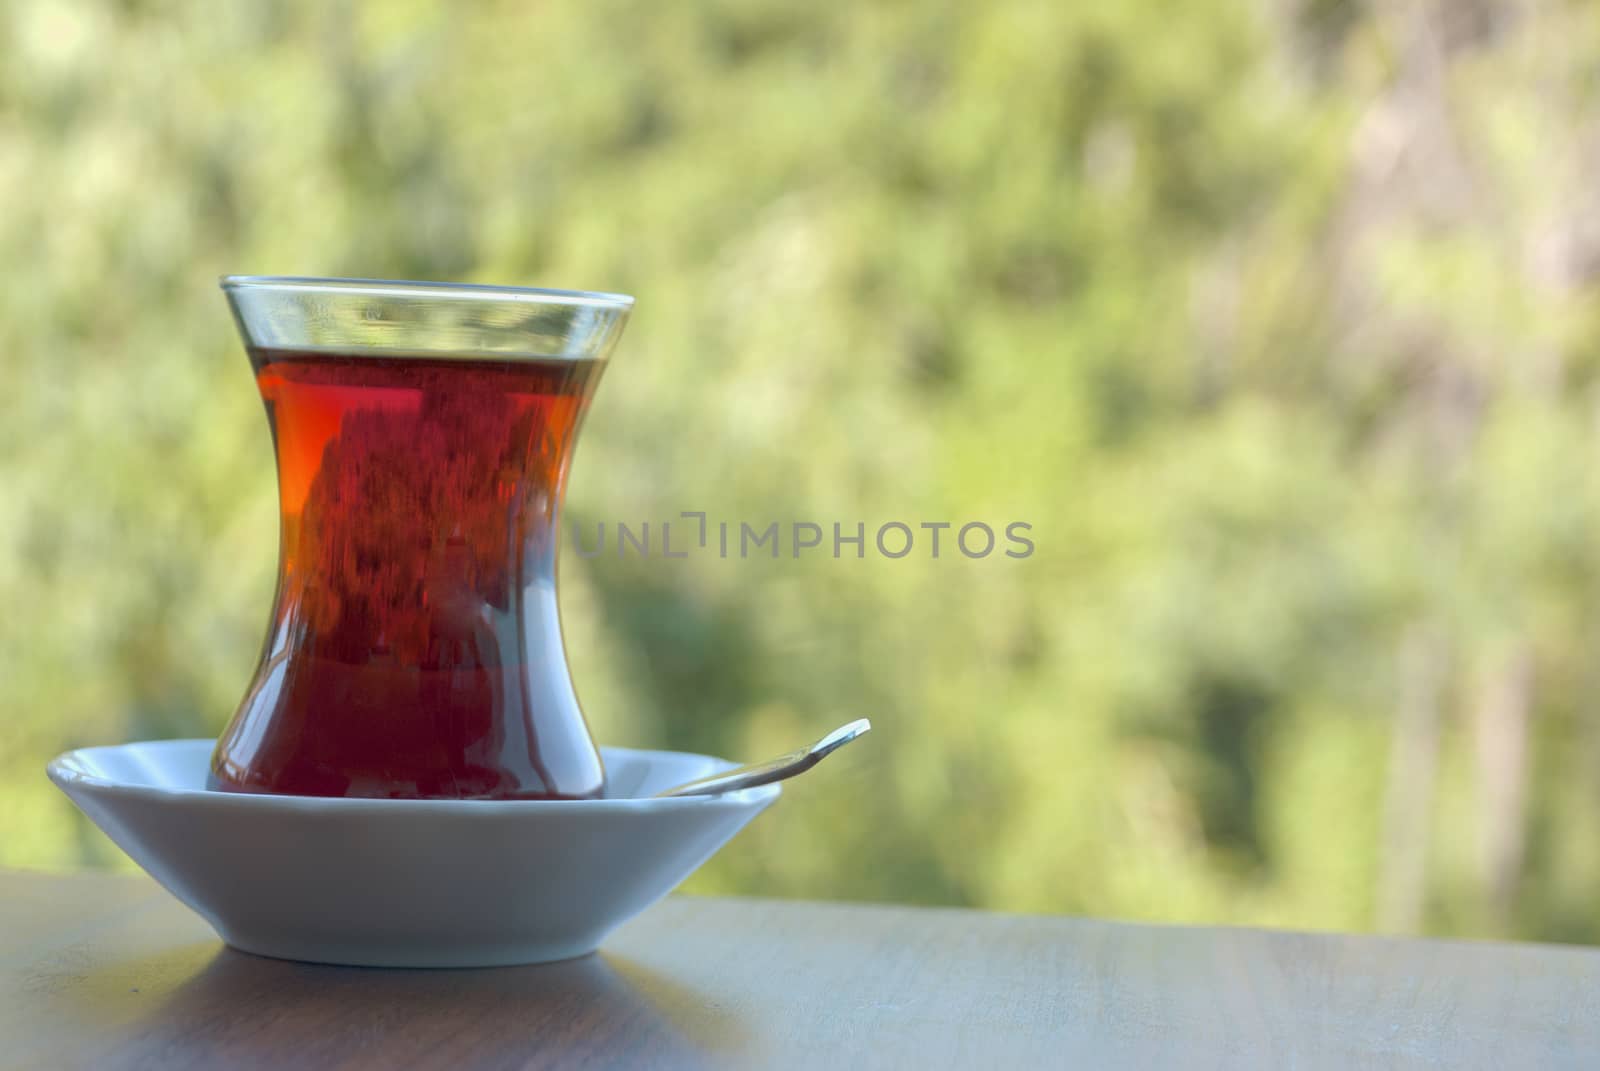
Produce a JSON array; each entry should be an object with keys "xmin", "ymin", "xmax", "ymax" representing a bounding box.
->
[{"xmin": 0, "ymin": 872, "xmax": 1600, "ymax": 1071}]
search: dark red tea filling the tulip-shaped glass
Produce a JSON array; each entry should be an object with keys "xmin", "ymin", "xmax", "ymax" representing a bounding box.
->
[{"xmin": 211, "ymin": 349, "xmax": 605, "ymax": 799}]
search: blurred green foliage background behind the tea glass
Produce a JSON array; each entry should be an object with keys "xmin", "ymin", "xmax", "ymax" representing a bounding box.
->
[{"xmin": 0, "ymin": 0, "xmax": 1600, "ymax": 941}]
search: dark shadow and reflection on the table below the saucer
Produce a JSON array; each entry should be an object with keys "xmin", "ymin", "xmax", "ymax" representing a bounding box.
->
[{"xmin": 54, "ymin": 946, "xmax": 746, "ymax": 1068}]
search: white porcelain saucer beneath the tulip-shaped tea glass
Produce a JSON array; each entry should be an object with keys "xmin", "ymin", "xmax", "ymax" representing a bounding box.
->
[{"xmin": 50, "ymin": 740, "xmax": 779, "ymax": 967}]
